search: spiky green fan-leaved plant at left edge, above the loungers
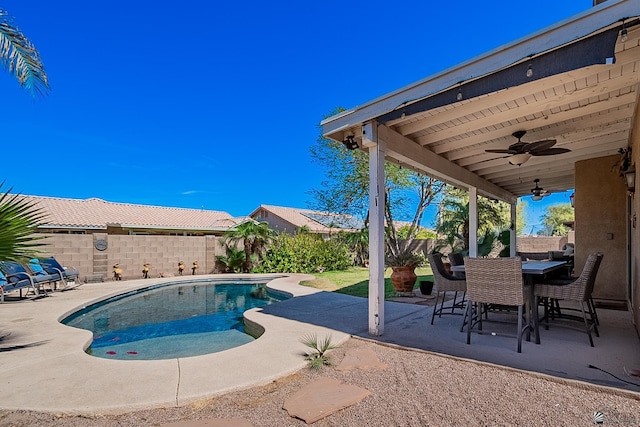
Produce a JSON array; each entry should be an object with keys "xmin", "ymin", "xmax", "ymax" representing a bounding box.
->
[{"xmin": 0, "ymin": 185, "xmax": 45, "ymax": 262}]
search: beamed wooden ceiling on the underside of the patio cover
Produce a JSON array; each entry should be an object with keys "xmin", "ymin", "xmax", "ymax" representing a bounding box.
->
[{"xmin": 323, "ymin": 5, "xmax": 640, "ymax": 199}]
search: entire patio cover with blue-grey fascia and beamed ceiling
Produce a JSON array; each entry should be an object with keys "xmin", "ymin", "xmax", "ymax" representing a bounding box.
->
[{"xmin": 322, "ymin": 0, "xmax": 640, "ymax": 203}]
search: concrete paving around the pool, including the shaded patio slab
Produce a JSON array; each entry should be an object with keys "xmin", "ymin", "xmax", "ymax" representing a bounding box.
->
[{"xmin": 0, "ymin": 275, "xmax": 640, "ymax": 414}]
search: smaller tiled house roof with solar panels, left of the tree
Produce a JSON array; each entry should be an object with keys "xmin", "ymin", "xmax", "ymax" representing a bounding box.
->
[{"xmin": 249, "ymin": 205, "xmax": 364, "ymax": 234}]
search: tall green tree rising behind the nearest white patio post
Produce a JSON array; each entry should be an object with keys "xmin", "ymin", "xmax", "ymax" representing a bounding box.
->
[{"xmin": 310, "ymin": 108, "xmax": 444, "ymax": 264}]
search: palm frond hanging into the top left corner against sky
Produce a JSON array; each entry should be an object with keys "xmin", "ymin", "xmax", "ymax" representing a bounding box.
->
[{"xmin": 0, "ymin": 9, "xmax": 50, "ymax": 96}]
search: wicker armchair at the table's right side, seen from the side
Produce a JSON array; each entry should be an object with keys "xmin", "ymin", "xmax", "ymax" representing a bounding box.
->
[{"xmin": 535, "ymin": 252, "xmax": 603, "ymax": 347}]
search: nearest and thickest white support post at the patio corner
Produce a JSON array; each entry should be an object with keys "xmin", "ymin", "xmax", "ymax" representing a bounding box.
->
[{"xmin": 362, "ymin": 122, "xmax": 385, "ymax": 336}]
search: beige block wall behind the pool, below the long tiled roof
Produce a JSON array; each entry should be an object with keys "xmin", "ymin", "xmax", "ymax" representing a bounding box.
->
[{"xmin": 37, "ymin": 233, "xmax": 225, "ymax": 280}]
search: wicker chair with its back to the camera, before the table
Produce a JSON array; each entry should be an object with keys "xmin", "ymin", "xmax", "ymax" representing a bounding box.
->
[{"xmin": 464, "ymin": 257, "xmax": 537, "ymax": 353}]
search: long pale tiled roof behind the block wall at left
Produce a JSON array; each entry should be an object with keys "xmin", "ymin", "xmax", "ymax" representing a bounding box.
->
[{"xmin": 22, "ymin": 195, "xmax": 238, "ymax": 230}]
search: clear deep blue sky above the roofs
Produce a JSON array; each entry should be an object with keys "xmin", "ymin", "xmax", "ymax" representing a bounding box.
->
[{"xmin": 0, "ymin": 0, "xmax": 592, "ymax": 232}]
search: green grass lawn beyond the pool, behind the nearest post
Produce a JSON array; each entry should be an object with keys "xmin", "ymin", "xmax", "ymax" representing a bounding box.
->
[{"xmin": 301, "ymin": 267, "xmax": 433, "ymax": 299}]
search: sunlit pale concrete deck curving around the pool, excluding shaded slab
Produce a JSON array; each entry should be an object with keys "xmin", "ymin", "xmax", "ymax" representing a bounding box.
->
[{"xmin": 0, "ymin": 275, "xmax": 349, "ymax": 414}]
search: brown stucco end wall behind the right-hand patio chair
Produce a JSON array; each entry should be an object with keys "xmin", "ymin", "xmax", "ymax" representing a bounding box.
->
[{"xmin": 575, "ymin": 155, "xmax": 627, "ymax": 301}]
